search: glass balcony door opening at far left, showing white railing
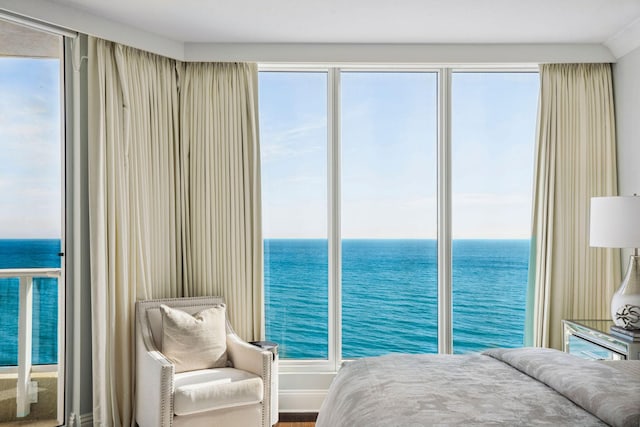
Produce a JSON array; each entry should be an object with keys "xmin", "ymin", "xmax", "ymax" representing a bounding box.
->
[{"xmin": 0, "ymin": 20, "xmax": 64, "ymax": 423}]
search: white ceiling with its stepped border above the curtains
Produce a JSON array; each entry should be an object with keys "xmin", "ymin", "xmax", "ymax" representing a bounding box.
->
[{"xmin": 0, "ymin": 0, "xmax": 640, "ymax": 61}]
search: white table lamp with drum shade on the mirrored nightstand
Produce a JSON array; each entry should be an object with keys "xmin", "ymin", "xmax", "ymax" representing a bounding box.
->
[{"xmin": 589, "ymin": 195, "xmax": 640, "ymax": 329}]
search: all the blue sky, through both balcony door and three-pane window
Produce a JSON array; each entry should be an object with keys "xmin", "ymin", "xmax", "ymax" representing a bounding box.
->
[{"xmin": 0, "ymin": 66, "xmax": 538, "ymax": 238}]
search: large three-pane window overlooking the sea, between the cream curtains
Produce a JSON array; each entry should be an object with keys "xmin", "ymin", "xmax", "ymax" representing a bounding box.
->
[{"xmin": 260, "ymin": 68, "xmax": 538, "ymax": 367}]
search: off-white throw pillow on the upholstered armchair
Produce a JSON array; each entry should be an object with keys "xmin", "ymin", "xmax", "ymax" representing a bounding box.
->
[{"xmin": 160, "ymin": 304, "xmax": 227, "ymax": 373}]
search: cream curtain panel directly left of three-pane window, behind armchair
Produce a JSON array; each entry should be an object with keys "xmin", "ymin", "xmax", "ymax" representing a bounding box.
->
[{"xmin": 180, "ymin": 63, "xmax": 264, "ymax": 340}]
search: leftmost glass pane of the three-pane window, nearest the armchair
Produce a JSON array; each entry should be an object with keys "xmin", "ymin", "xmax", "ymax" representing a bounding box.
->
[{"xmin": 259, "ymin": 72, "xmax": 329, "ymax": 359}]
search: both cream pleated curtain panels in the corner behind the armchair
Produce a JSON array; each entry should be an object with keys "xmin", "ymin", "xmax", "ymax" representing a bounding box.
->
[{"xmin": 88, "ymin": 38, "xmax": 263, "ymax": 426}]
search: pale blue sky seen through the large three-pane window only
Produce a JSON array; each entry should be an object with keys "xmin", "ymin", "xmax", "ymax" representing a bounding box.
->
[{"xmin": 260, "ymin": 72, "xmax": 538, "ymax": 239}]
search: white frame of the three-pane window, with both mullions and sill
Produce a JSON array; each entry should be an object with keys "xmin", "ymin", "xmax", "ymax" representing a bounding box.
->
[{"xmin": 258, "ymin": 63, "xmax": 539, "ymax": 374}]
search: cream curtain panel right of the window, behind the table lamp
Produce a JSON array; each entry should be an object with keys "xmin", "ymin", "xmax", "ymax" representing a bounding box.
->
[{"xmin": 526, "ymin": 64, "xmax": 620, "ymax": 349}]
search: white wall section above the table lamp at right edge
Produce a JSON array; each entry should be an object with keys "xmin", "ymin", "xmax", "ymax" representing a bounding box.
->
[{"xmin": 613, "ymin": 48, "xmax": 640, "ymax": 195}]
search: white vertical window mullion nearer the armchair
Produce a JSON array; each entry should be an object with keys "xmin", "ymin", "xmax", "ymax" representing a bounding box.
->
[{"xmin": 327, "ymin": 68, "xmax": 342, "ymax": 370}]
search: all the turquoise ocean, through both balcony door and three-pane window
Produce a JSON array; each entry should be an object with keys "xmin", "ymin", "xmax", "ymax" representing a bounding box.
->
[{"xmin": 0, "ymin": 239, "xmax": 529, "ymax": 366}]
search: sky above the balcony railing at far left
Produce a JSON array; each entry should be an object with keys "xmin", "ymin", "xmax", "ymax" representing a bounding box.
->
[{"xmin": 0, "ymin": 57, "xmax": 62, "ymax": 239}]
